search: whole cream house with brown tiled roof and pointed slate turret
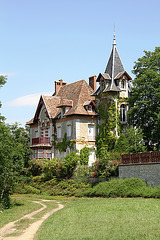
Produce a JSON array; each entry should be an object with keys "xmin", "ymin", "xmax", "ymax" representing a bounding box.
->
[{"xmin": 27, "ymin": 34, "xmax": 131, "ymax": 165}]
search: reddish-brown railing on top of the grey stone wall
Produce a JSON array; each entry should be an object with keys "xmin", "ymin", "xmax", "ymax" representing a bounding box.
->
[{"xmin": 121, "ymin": 152, "xmax": 160, "ymax": 164}]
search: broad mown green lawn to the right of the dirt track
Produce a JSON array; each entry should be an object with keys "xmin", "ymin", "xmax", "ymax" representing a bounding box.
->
[{"xmin": 35, "ymin": 198, "xmax": 160, "ymax": 240}]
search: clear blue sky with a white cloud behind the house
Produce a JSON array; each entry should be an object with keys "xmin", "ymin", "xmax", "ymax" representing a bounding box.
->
[{"xmin": 0, "ymin": 0, "xmax": 160, "ymax": 126}]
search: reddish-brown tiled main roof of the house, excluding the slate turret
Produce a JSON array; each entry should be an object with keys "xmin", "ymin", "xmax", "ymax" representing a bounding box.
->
[{"xmin": 28, "ymin": 80, "xmax": 96, "ymax": 124}]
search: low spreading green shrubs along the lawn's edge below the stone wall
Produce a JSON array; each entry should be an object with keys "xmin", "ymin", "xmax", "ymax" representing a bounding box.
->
[{"xmin": 82, "ymin": 178, "xmax": 160, "ymax": 198}]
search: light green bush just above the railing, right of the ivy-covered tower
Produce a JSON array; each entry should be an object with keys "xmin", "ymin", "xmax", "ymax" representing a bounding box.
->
[{"xmin": 114, "ymin": 127, "xmax": 146, "ymax": 153}]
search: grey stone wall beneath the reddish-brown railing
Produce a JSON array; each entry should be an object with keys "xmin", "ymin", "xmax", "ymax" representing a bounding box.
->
[{"xmin": 119, "ymin": 163, "xmax": 160, "ymax": 187}]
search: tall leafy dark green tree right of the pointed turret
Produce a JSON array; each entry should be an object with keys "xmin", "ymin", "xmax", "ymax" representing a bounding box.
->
[{"xmin": 128, "ymin": 47, "xmax": 160, "ymax": 150}]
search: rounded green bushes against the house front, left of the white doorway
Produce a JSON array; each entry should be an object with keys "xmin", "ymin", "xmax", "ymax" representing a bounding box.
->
[{"xmin": 43, "ymin": 152, "xmax": 79, "ymax": 180}]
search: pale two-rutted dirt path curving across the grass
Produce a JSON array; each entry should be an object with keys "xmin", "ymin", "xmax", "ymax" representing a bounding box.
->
[{"xmin": 0, "ymin": 200, "xmax": 64, "ymax": 240}]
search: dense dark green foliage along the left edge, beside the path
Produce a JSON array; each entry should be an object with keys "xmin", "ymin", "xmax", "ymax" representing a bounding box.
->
[{"xmin": 0, "ymin": 122, "xmax": 30, "ymax": 207}]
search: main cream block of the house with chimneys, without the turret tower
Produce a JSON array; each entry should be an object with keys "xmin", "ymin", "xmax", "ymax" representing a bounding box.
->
[{"xmin": 27, "ymin": 76, "xmax": 97, "ymax": 165}]
